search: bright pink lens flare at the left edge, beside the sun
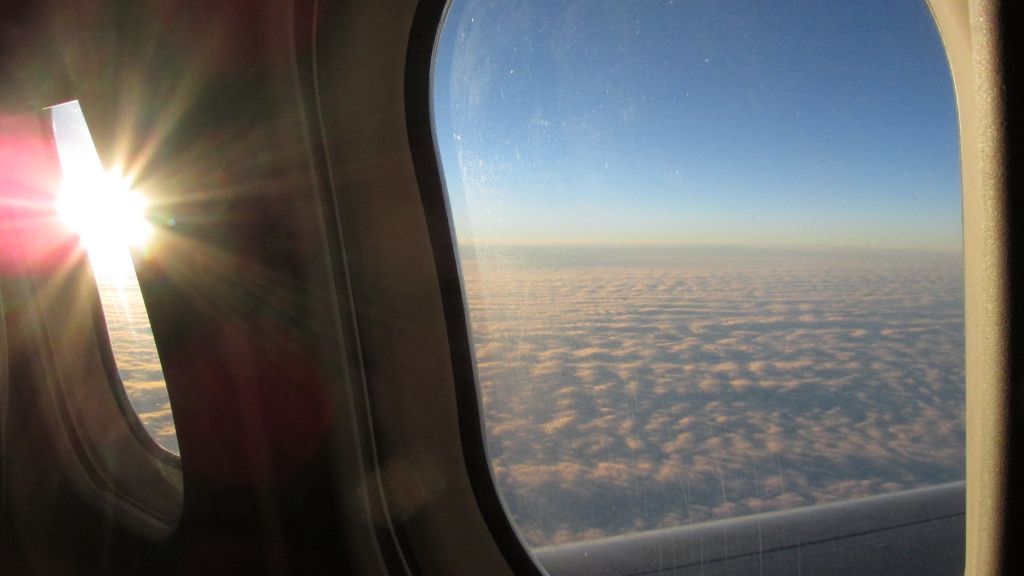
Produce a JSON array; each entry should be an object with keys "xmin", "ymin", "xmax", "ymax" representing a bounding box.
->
[{"xmin": 0, "ymin": 112, "xmax": 77, "ymax": 276}]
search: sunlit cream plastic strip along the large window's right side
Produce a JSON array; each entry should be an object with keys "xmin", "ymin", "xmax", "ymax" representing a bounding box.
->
[{"xmin": 928, "ymin": 0, "xmax": 1019, "ymax": 575}]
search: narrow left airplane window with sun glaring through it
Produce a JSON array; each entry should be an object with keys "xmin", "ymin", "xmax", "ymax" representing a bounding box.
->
[{"xmin": 50, "ymin": 101, "xmax": 178, "ymax": 454}]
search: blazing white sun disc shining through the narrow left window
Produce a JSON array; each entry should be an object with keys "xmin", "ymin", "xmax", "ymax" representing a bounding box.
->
[{"xmin": 56, "ymin": 170, "xmax": 153, "ymax": 274}]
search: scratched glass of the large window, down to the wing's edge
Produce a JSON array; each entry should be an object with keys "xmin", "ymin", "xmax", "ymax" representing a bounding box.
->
[{"xmin": 433, "ymin": 0, "xmax": 965, "ymax": 546}]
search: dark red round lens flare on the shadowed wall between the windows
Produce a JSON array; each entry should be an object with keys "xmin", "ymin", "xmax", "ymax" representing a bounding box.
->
[{"xmin": 174, "ymin": 319, "xmax": 332, "ymax": 485}]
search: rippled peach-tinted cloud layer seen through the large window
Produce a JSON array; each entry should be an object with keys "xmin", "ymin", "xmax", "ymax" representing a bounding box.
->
[{"xmin": 464, "ymin": 248, "xmax": 965, "ymax": 545}]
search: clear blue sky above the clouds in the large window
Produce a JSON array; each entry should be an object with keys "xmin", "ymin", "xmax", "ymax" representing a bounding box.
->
[{"xmin": 433, "ymin": 0, "xmax": 962, "ymax": 251}]
